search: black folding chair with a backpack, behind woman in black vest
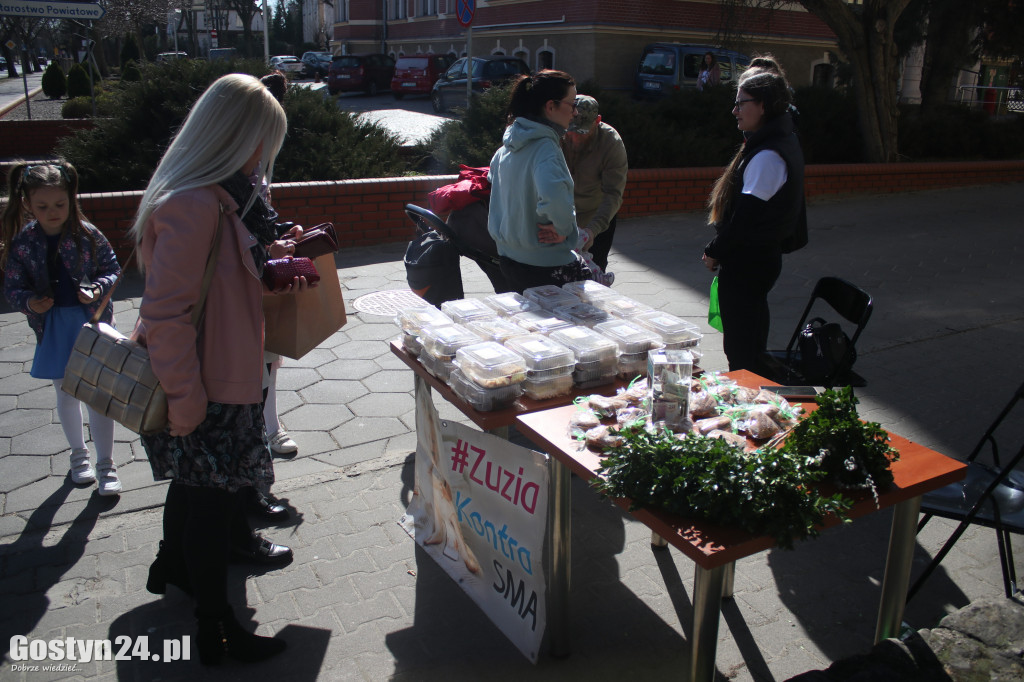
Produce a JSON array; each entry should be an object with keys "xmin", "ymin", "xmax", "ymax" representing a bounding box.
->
[{"xmin": 765, "ymin": 278, "xmax": 872, "ymax": 388}]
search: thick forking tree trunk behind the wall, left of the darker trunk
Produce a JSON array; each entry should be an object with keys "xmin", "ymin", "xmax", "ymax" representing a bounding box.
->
[{"xmin": 800, "ymin": 0, "xmax": 910, "ymax": 163}]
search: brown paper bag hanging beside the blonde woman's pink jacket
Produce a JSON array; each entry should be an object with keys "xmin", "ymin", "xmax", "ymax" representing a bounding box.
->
[{"xmin": 263, "ymin": 253, "xmax": 345, "ymax": 359}]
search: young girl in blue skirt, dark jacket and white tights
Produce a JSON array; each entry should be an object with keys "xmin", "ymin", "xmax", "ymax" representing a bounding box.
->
[{"xmin": 0, "ymin": 161, "xmax": 121, "ymax": 495}]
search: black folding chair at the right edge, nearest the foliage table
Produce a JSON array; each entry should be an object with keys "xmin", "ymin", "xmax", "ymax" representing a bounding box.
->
[{"xmin": 906, "ymin": 383, "xmax": 1024, "ymax": 601}]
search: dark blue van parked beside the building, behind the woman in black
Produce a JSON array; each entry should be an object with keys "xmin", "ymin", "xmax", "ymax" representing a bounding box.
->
[{"xmin": 633, "ymin": 43, "xmax": 751, "ymax": 99}]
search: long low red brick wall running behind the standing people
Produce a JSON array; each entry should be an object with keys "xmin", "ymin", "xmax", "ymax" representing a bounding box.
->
[{"xmin": 75, "ymin": 161, "xmax": 1024, "ymax": 264}]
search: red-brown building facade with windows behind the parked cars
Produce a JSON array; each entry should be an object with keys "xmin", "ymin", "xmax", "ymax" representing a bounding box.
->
[{"xmin": 323, "ymin": 0, "xmax": 837, "ymax": 89}]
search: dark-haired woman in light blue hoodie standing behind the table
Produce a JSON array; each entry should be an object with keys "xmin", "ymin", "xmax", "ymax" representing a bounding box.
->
[{"xmin": 487, "ymin": 70, "xmax": 592, "ymax": 293}]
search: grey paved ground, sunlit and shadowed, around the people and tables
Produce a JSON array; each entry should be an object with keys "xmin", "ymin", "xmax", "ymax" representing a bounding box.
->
[{"xmin": 0, "ymin": 184, "xmax": 1024, "ymax": 681}]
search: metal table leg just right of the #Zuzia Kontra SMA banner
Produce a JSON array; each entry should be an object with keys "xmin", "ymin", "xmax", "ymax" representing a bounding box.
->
[{"xmin": 548, "ymin": 457, "xmax": 572, "ymax": 658}]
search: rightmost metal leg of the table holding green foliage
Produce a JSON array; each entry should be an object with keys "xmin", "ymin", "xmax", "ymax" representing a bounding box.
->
[{"xmin": 874, "ymin": 496, "xmax": 921, "ymax": 644}]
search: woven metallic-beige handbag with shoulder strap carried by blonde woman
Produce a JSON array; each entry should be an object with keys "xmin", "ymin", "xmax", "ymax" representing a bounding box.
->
[{"xmin": 60, "ymin": 212, "xmax": 223, "ymax": 434}]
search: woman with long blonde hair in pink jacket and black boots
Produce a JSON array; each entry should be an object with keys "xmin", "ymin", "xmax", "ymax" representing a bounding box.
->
[{"xmin": 132, "ymin": 74, "xmax": 306, "ymax": 665}]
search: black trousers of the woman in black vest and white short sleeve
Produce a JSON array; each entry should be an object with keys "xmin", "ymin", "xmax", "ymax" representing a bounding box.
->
[{"xmin": 718, "ymin": 250, "xmax": 782, "ymax": 376}]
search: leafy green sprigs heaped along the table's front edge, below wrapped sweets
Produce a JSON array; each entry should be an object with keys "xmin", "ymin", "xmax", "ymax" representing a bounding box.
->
[{"xmin": 594, "ymin": 423, "xmax": 850, "ymax": 549}]
